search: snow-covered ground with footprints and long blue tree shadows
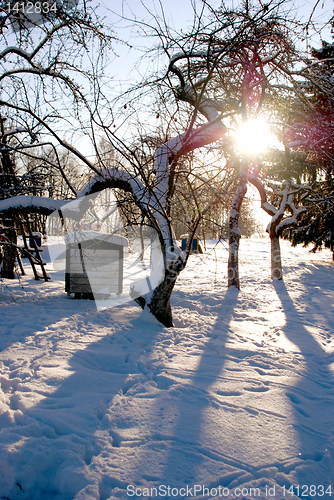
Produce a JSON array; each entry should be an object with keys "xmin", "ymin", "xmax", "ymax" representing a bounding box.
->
[{"xmin": 0, "ymin": 238, "xmax": 334, "ymax": 500}]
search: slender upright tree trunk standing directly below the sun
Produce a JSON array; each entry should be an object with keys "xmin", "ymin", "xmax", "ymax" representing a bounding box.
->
[{"xmin": 227, "ymin": 166, "xmax": 247, "ymax": 290}]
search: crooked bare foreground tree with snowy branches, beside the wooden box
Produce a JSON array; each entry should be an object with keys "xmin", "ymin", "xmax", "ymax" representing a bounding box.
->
[{"xmin": 0, "ymin": 5, "xmax": 228, "ymax": 326}]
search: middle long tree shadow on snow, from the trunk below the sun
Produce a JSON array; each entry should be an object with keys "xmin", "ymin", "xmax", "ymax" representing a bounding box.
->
[{"xmin": 154, "ymin": 287, "xmax": 241, "ymax": 494}]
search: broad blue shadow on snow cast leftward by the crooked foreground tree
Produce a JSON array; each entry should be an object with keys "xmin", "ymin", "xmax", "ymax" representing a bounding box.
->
[{"xmin": 0, "ymin": 301, "xmax": 166, "ymax": 500}]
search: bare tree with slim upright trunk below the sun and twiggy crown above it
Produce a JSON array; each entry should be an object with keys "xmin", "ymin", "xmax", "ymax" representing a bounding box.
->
[{"xmin": 153, "ymin": 1, "xmax": 297, "ymax": 288}]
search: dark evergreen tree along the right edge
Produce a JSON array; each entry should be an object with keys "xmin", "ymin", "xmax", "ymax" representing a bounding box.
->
[{"xmin": 286, "ymin": 29, "xmax": 334, "ymax": 251}]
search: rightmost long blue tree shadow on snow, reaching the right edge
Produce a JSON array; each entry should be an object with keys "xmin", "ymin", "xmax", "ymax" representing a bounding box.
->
[{"xmin": 274, "ymin": 274, "xmax": 334, "ymax": 487}]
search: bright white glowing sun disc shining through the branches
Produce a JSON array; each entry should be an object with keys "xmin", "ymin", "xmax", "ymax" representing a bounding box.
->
[{"xmin": 236, "ymin": 118, "xmax": 275, "ymax": 154}]
